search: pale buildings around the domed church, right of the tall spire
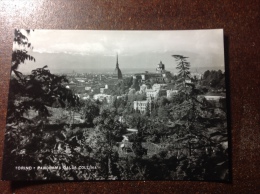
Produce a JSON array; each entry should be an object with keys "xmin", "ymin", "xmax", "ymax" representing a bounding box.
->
[{"xmin": 133, "ymin": 62, "xmax": 226, "ymax": 113}]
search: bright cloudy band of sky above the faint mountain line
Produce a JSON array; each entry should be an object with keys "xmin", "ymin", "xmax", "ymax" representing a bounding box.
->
[{"xmin": 29, "ymin": 30, "xmax": 223, "ymax": 55}]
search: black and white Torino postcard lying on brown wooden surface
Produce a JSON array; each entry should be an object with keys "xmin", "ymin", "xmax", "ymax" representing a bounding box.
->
[{"xmin": 2, "ymin": 29, "xmax": 230, "ymax": 181}]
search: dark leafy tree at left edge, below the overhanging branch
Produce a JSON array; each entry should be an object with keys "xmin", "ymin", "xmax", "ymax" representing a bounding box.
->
[{"xmin": 7, "ymin": 66, "xmax": 78, "ymax": 123}]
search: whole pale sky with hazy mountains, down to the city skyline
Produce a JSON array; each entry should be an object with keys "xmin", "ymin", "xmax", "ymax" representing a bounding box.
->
[{"xmin": 14, "ymin": 29, "xmax": 224, "ymax": 73}]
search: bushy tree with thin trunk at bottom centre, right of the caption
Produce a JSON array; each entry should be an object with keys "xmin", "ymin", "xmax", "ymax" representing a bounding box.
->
[{"xmin": 87, "ymin": 109, "xmax": 126, "ymax": 179}]
